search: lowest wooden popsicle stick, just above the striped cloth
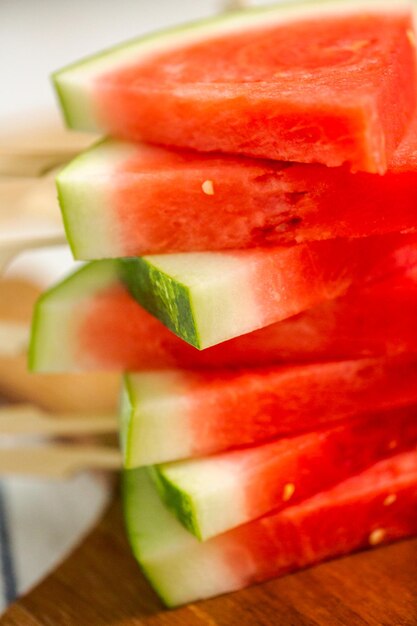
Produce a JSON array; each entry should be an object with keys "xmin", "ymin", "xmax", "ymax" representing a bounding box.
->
[{"xmin": 0, "ymin": 444, "xmax": 121, "ymax": 478}]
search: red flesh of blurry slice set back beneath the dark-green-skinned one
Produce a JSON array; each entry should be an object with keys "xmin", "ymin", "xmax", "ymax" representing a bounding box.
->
[{"xmin": 73, "ymin": 268, "xmax": 417, "ymax": 370}]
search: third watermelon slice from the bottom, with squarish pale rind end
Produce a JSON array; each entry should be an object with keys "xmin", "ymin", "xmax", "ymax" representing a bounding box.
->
[{"xmin": 121, "ymin": 357, "xmax": 417, "ymax": 468}]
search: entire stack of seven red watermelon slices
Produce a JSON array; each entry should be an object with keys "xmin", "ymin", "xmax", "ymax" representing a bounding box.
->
[{"xmin": 31, "ymin": 0, "xmax": 417, "ymax": 606}]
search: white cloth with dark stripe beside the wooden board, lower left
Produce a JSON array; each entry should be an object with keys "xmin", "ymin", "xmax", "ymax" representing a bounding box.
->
[{"xmin": 0, "ymin": 472, "xmax": 110, "ymax": 613}]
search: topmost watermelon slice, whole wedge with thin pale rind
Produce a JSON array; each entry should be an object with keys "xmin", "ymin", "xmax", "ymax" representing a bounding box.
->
[{"xmin": 54, "ymin": 0, "xmax": 417, "ymax": 173}]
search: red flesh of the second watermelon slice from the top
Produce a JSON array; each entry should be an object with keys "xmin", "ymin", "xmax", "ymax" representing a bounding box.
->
[{"xmin": 103, "ymin": 117, "xmax": 417, "ymax": 256}]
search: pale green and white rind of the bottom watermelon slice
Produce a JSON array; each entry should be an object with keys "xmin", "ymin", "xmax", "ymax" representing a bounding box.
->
[{"xmin": 125, "ymin": 470, "xmax": 245, "ymax": 606}]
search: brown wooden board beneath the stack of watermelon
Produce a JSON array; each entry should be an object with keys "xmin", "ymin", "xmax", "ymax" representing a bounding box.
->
[{"xmin": 0, "ymin": 492, "xmax": 417, "ymax": 626}]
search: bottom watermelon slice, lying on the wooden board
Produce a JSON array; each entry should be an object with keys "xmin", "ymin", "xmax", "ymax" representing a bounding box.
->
[{"xmin": 123, "ymin": 451, "xmax": 417, "ymax": 606}]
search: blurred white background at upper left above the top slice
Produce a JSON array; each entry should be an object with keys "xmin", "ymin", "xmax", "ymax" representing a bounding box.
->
[{"xmin": 0, "ymin": 0, "xmax": 272, "ymax": 118}]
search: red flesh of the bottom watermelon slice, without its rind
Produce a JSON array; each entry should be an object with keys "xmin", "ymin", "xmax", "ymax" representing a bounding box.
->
[{"xmin": 218, "ymin": 451, "xmax": 417, "ymax": 584}]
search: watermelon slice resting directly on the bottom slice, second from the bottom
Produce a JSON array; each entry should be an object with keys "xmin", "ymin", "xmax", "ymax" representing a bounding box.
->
[{"xmin": 151, "ymin": 405, "xmax": 417, "ymax": 540}]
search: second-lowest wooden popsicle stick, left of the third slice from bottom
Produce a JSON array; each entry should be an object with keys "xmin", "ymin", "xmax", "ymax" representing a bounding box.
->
[{"xmin": 0, "ymin": 404, "xmax": 118, "ymax": 437}]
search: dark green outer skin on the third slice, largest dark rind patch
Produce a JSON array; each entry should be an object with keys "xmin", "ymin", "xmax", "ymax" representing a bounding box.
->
[{"xmin": 120, "ymin": 257, "xmax": 202, "ymax": 349}]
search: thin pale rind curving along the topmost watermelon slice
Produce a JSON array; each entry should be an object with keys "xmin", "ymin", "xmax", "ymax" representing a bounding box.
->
[{"xmin": 52, "ymin": 0, "xmax": 410, "ymax": 131}]
